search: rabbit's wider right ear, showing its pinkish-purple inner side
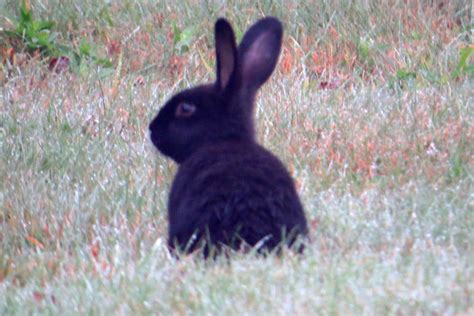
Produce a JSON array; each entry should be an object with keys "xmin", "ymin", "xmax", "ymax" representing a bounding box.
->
[{"xmin": 239, "ymin": 17, "xmax": 283, "ymax": 91}]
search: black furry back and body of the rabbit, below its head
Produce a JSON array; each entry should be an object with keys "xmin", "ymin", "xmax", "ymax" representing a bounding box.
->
[{"xmin": 168, "ymin": 141, "xmax": 308, "ymax": 252}]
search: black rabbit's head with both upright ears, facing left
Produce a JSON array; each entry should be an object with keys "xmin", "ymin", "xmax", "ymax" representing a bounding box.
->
[{"xmin": 150, "ymin": 17, "xmax": 283, "ymax": 163}]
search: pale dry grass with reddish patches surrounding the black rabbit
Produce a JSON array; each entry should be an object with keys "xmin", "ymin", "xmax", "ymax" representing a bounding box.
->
[{"xmin": 0, "ymin": 0, "xmax": 474, "ymax": 315}]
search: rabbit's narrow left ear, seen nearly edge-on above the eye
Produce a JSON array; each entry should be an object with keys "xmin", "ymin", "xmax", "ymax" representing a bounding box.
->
[{"xmin": 214, "ymin": 18, "xmax": 237, "ymax": 90}]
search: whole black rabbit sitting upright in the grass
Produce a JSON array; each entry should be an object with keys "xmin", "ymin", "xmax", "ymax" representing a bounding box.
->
[{"xmin": 149, "ymin": 17, "xmax": 308, "ymax": 257}]
